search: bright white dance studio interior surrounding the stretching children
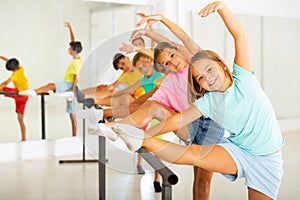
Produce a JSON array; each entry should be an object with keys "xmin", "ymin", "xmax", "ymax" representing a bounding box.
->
[{"xmin": 0, "ymin": 0, "xmax": 300, "ymax": 200}]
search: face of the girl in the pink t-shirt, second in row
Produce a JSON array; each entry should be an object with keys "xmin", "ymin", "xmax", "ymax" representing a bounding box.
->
[{"xmin": 157, "ymin": 49, "xmax": 188, "ymax": 72}]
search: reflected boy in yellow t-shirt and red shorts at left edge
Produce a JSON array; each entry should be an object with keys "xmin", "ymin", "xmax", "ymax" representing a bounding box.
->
[{"xmin": 0, "ymin": 56, "xmax": 29, "ymax": 141}]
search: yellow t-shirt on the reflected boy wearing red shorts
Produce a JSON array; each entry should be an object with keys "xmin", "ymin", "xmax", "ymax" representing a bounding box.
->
[{"xmin": 10, "ymin": 66, "xmax": 29, "ymax": 91}]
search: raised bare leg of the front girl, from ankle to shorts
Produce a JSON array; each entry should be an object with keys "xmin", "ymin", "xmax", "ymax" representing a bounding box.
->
[{"xmin": 143, "ymin": 137, "xmax": 237, "ymax": 174}]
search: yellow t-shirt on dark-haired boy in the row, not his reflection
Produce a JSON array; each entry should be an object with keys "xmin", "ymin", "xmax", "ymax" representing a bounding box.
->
[{"xmin": 118, "ymin": 69, "xmax": 145, "ymax": 97}]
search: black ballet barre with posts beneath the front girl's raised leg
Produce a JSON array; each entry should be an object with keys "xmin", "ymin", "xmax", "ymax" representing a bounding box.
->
[{"xmin": 98, "ymin": 136, "xmax": 178, "ymax": 200}]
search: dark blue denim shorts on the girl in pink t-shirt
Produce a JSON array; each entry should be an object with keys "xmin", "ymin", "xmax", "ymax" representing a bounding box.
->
[{"xmin": 188, "ymin": 116, "xmax": 224, "ymax": 145}]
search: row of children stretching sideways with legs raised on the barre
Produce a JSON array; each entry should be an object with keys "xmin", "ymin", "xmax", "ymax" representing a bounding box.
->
[{"xmin": 1, "ymin": 2, "xmax": 284, "ymax": 200}]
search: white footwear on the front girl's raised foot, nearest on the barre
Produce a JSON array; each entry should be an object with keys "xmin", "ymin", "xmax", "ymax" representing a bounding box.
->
[{"xmin": 111, "ymin": 124, "xmax": 144, "ymax": 151}]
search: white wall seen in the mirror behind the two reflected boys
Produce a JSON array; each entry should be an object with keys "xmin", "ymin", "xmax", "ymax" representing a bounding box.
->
[{"xmin": 0, "ymin": 0, "xmax": 99, "ymax": 142}]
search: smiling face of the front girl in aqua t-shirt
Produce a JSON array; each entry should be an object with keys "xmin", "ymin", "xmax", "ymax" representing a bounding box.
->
[{"xmin": 192, "ymin": 59, "xmax": 231, "ymax": 92}]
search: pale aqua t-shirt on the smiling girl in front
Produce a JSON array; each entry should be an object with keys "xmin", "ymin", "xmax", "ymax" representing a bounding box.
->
[{"xmin": 194, "ymin": 64, "xmax": 284, "ymax": 155}]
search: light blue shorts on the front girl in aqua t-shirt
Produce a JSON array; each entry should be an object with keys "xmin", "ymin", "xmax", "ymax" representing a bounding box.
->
[{"xmin": 218, "ymin": 139, "xmax": 283, "ymax": 199}]
